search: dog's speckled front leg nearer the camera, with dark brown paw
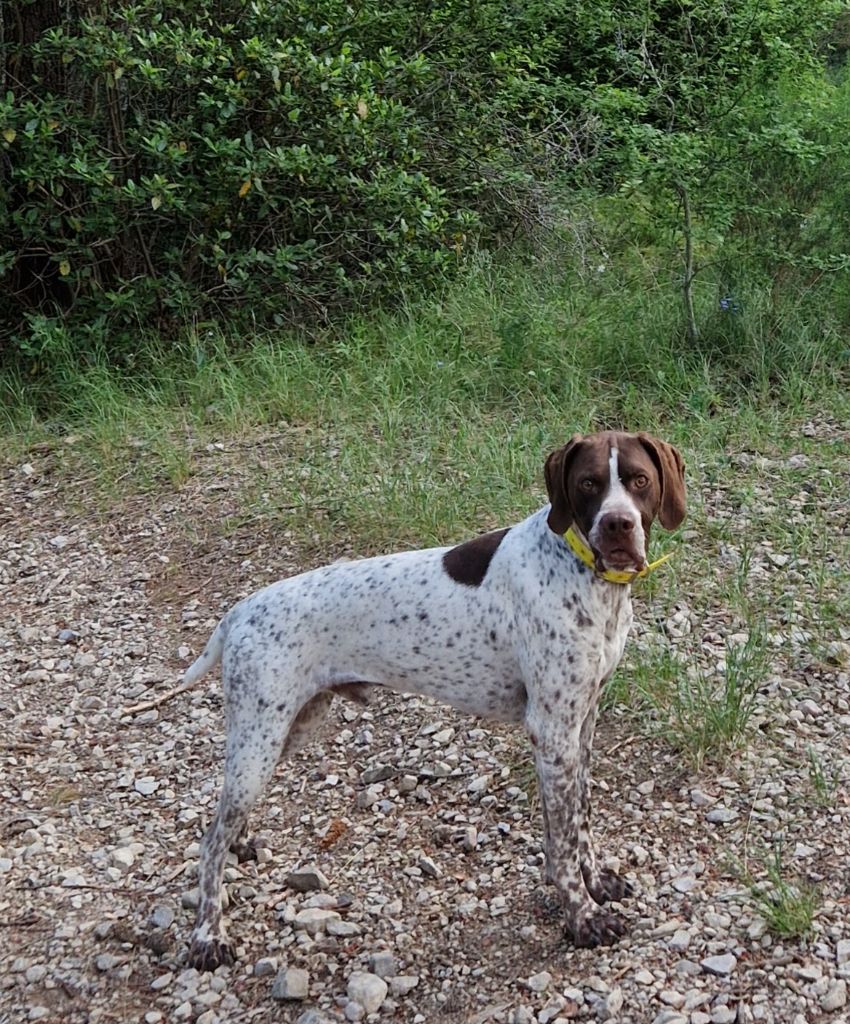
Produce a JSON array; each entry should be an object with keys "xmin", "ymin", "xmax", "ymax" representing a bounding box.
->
[{"xmin": 526, "ymin": 703, "xmax": 625, "ymax": 946}]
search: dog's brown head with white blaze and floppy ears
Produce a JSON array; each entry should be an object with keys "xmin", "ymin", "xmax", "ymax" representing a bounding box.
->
[{"xmin": 545, "ymin": 431, "xmax": 685, "ymax": 571}]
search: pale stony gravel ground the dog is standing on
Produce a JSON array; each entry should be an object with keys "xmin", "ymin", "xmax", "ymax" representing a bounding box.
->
[{"xmin": 0, "ymin": 425, "xmax": 850, "ymax": 1024}]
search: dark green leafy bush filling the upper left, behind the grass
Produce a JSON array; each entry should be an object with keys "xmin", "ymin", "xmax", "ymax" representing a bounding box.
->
[{"xmin": 0, "ymin": 0, "xmax": 573, "ymax": 356}]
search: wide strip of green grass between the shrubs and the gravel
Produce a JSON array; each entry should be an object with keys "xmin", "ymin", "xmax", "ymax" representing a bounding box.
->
[{"xmin": 0, "ymin": 248, "xmax": 850, "ymax": 557}]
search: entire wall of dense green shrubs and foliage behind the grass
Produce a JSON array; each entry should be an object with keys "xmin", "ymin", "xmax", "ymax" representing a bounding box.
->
[{"xmin": 0, "ymin": 0, "xmax": 841, "ymax": 359}]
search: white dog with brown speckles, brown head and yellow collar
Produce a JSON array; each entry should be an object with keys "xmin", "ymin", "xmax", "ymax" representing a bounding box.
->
[{"xmin": 180, "ymin": 432, "xmax": 685, "ymax": 970}]
